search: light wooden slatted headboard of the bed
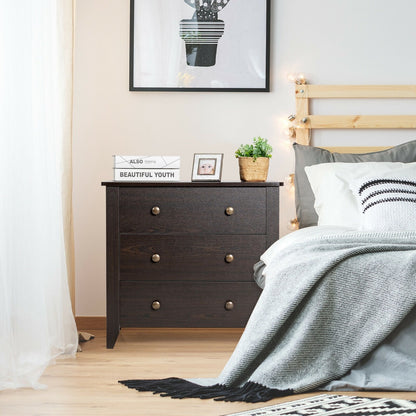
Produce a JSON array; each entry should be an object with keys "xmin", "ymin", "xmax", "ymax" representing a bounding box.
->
[{"xmin": 291, "ymin": 82, "xmax": 416, "ymax": 145}]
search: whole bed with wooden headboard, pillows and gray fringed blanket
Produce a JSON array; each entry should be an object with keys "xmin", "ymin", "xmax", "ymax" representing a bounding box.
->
[{"xmin": 121, "ymin": 83, "xmax": 416, "ymax": 402}]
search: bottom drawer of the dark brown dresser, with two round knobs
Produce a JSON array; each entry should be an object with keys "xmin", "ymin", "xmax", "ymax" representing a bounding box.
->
[{"xmin": 120, "ymin": 281, "xmax": 261, "ymax": 328}]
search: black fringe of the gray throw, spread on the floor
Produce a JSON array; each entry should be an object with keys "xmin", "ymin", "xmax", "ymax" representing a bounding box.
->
[{"xmin": 119, "ymin": 377, "xmax": 294, "ymax": 403}]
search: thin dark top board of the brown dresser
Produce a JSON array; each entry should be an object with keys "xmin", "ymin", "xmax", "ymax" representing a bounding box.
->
[{"xmin": 101, "ymin": 181, "xmax": 283, "ymax": 188}]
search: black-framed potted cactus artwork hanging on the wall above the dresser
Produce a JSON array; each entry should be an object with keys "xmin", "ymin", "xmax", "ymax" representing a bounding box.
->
[{"xmin": 130, "ymin": 0, "xmax": 271, "ymax": 92}]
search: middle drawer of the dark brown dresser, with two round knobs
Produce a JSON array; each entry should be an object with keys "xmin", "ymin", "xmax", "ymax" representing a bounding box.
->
[{"xmin": 120, "ymin": 234, "xmax": 266, "ymax": 281}]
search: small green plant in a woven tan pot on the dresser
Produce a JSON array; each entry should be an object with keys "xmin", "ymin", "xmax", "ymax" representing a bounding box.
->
[{"xmin": 235, "ymin": 137, "xmax": 273, "ymax": 182}]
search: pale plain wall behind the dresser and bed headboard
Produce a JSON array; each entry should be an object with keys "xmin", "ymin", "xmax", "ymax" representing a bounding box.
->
[{"xmin": 73, "ymin": 0, "xmax": 416, "ymax": 316}]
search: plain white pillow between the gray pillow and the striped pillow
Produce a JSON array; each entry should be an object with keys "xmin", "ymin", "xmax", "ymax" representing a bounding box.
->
[{"xmin": 305, "ymin": 162, "xmax": 416, "ymax": 229}]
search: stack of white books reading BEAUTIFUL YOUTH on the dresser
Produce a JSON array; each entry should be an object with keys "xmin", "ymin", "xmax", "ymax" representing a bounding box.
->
[{"xmin": 114, "ymin": 156, "xmax": 181, "ymax": 182}]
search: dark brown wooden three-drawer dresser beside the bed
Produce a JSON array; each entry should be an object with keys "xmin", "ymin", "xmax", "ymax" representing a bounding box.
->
[{"xmin": 102, "ymin": 182, "xmax": 282, "ymax": 348}]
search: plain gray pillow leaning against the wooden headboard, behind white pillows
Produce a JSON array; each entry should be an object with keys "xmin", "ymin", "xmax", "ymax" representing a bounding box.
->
[{"xmin": 293, "ymin": 140, "xmax": 416, "ymax": 228}]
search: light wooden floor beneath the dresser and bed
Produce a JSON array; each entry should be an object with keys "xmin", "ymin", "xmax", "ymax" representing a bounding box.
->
[{"xmin": 0, "ymin": 329, "xmax": 416, "ymax": 416}]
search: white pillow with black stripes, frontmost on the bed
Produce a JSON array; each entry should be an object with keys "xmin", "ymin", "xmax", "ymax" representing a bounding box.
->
[{"xmin": 355, "ymin": 177, "xmax": 416, "ymax": 231}]
